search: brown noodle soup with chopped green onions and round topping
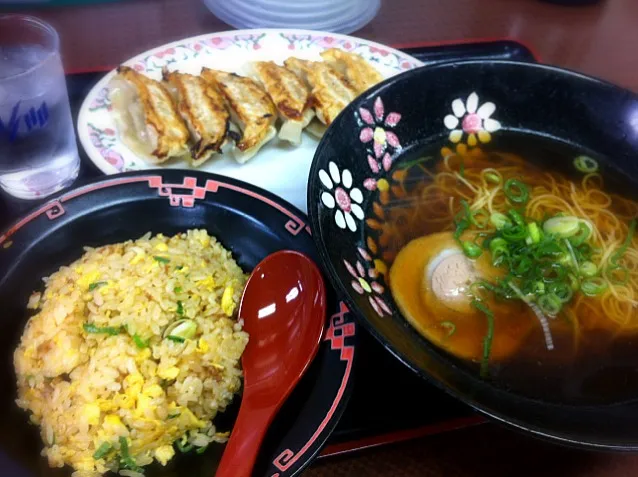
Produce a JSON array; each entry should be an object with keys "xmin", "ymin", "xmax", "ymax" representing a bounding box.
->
[{"xmin": 376, "ymin": 136, "xmax": 638, "ymax": 404}]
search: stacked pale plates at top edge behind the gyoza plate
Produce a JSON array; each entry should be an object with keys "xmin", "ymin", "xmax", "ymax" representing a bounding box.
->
[{"xmin": 204, "ymin": 0, "xmax": 381, "ymax": 33}]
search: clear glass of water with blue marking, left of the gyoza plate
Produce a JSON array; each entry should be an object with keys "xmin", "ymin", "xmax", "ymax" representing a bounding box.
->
[{"xmin": 0, "ymin": 15, "xmax": 80, "ymax": 199}]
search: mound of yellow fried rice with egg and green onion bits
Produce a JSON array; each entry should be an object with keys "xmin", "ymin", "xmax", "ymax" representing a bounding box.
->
[{"xmin": 14, "ymin": 230, "xmax": 248, "ymax": 477}]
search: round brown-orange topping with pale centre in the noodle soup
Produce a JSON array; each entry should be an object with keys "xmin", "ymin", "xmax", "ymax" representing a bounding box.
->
[{"xmin": 389, "ymin": 232, "xmax": 533, "ymax": 362}]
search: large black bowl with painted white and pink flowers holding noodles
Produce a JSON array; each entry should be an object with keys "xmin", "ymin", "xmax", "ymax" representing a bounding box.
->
[{"xmin": 308, "ymin": 61, "xmax": 638, "ymax": 451}]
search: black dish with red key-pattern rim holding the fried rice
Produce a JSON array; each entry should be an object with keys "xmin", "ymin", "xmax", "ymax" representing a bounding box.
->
[{"xmin": 0, "ymin": 170, "xmax": 357, "ymax": 477}]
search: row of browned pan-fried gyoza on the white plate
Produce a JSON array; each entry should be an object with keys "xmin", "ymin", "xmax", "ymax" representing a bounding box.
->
[{"xmin": 109, "ymin": 48, "xmax": 383, "ymax": 167}]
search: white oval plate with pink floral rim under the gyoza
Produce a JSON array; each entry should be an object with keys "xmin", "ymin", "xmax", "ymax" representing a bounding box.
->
[{"xmin": 78, "ymin": 29, "xmax": 422, "ymax": 212}]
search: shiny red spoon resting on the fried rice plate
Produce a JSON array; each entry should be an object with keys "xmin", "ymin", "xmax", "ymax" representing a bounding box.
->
[{"xmin": 215, "ymin": 250, "xmax": 326, "ymax": 477}]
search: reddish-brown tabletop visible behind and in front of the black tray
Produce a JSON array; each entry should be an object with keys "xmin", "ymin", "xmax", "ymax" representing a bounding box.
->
[{"xmin": 7, "ymin": 0, "xmax": 638, "ymax": 477}]
